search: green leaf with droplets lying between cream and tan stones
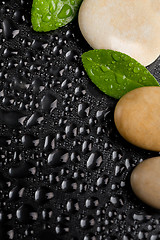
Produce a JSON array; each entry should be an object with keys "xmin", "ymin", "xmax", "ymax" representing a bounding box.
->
[{"xmin": 82, "ymin": 49, "xmax": 159, "ymax": 99}]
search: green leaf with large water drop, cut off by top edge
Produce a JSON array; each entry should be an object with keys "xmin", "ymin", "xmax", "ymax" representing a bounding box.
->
[{"xmin": 31, "ymin": 0, "xmax": 82, "ymax": 32}]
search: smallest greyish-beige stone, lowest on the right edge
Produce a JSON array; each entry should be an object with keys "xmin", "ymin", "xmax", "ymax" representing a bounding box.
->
[{"xmin": 130, "ymin": 157, "xmax": 160, "ymax": 209}]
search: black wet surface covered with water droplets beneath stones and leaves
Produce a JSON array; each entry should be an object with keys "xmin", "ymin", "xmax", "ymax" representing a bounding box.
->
[{"xmin": 0, "ymin": 0, "xmax": 160, "ymax": 240}]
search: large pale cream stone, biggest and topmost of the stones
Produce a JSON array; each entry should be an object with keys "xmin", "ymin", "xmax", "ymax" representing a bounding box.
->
[{"xmin": 78, "ymin": 0, "xmax": 160, "ymax": 66}]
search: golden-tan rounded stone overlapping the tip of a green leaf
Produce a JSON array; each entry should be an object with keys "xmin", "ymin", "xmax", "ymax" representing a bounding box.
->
[{"xmin": 114, "ymin": 87, "xmax": 160, "ymax": 151}]
